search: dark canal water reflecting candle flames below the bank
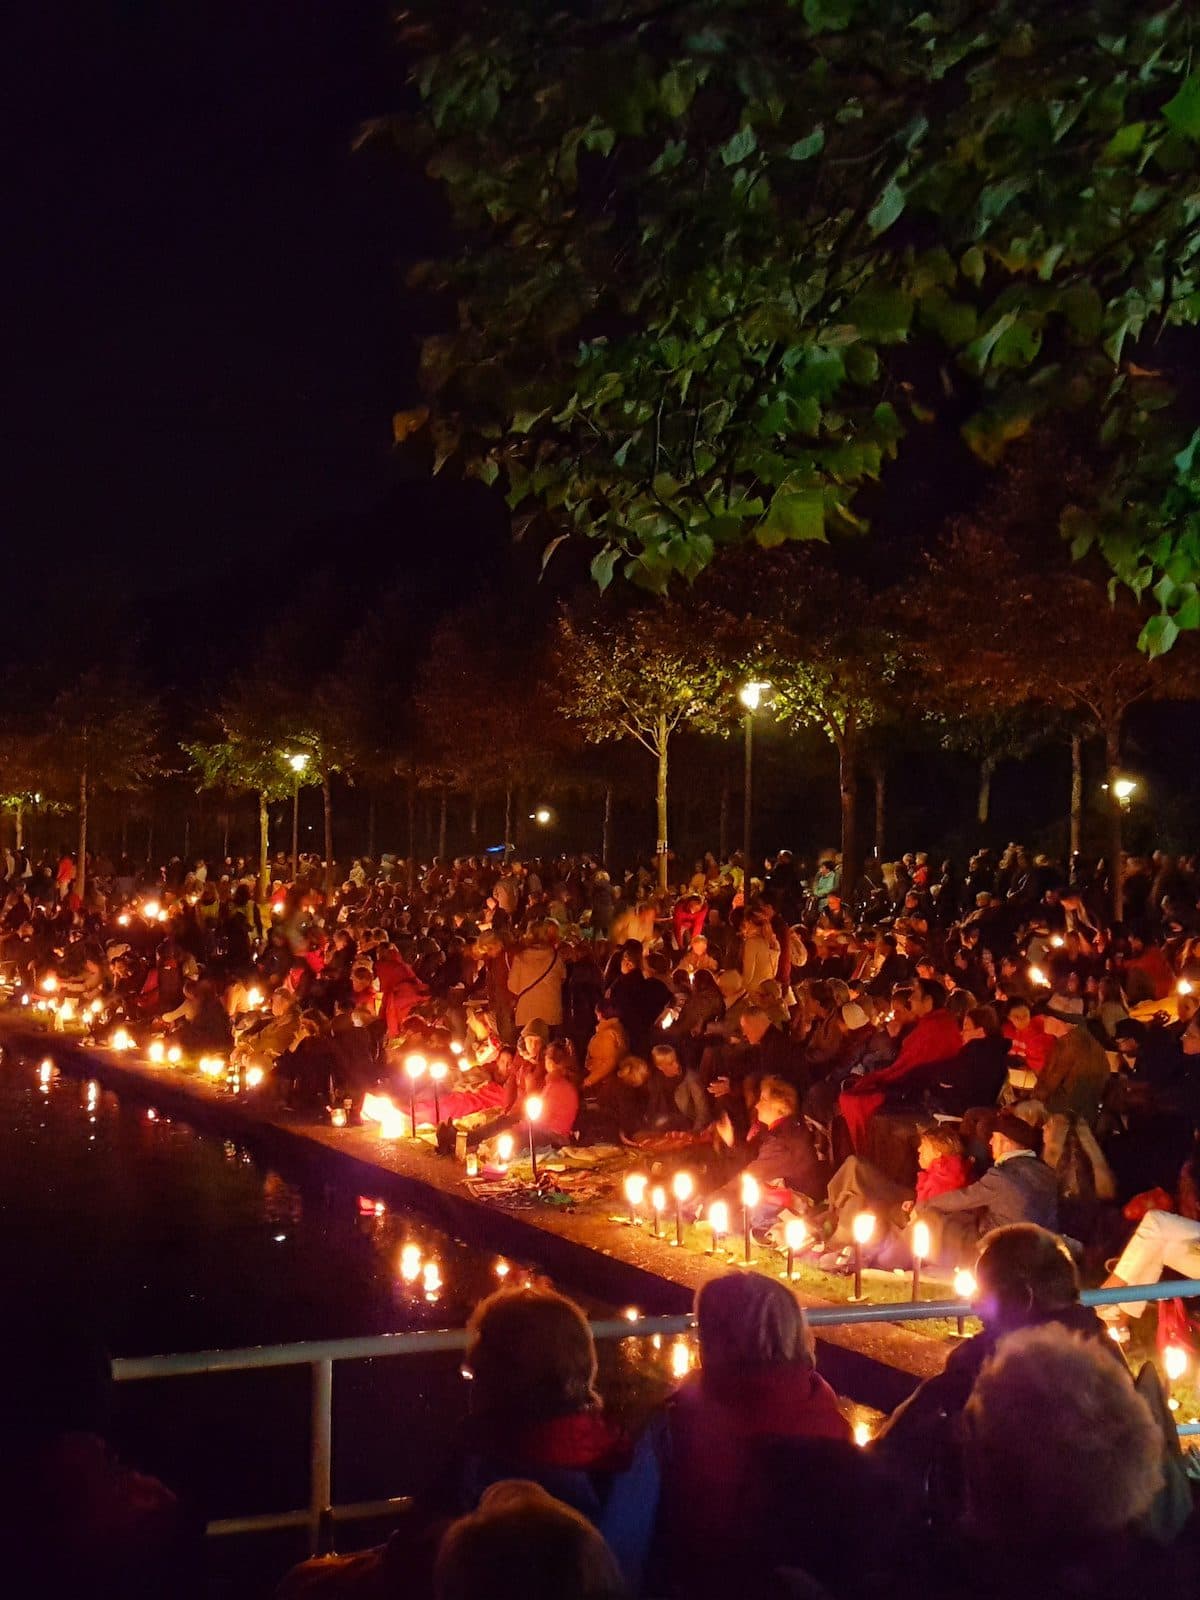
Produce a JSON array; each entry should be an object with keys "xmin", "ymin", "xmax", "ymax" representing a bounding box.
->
[{"xmin": 0, "ymin": 1050, "xmax": 682, "ymax": 1595}]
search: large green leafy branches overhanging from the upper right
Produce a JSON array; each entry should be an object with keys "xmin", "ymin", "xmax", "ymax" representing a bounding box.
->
[{"xmin": 397, "ymin": 0, "xmax": 1200, "ymax": 626}]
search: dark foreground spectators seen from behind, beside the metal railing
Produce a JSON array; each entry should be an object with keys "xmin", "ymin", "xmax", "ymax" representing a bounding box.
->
[{"xmin": 11, "ymin": 1224, "xmax": 1200, "ymax": 1600}]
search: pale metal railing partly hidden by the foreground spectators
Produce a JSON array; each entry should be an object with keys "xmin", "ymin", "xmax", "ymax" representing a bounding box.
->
[{"xmin": 112, "ymin": 1278, "xmax": 1200, "ymax": 1552}]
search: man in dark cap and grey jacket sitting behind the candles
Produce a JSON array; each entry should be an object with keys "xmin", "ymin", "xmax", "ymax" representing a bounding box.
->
[{"xmin": 920, "ymin": 1110, "xmax": 1058, "ymax": 1267}]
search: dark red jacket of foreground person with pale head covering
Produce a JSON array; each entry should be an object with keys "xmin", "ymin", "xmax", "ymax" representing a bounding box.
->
[{"xmin": 662, "ymin": 1365, "xmax": 851, "ymax": 1562}]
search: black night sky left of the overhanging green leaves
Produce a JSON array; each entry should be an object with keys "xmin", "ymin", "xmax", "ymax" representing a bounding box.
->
[{"xmin": 0, "ymin": 0, "xmax": 464, "ymax": 630}]
